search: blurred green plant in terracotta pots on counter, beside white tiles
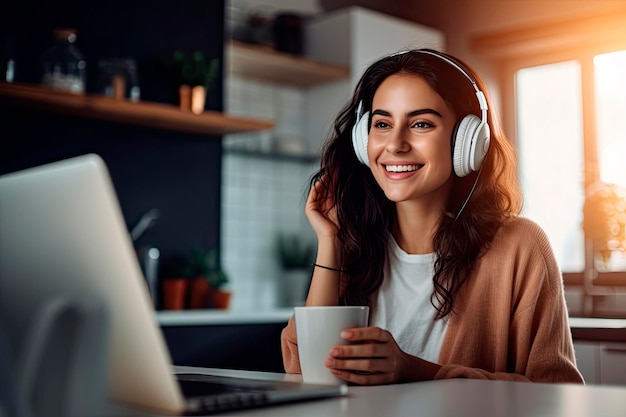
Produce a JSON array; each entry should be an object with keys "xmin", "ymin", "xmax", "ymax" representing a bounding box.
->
[{"xmin": 183, "ymin": 248, "xmax": 231, "ymax": 309}]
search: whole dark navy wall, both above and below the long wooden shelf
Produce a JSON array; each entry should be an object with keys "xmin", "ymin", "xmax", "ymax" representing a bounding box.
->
[{"xmin": 0, "ymin": 0, "xmax": 224, "ymax": 306}]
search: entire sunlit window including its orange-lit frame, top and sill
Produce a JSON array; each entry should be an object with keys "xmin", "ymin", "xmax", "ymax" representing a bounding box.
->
[{"xmin": 470, "ymin": 8, "xmax": 626, "ymax": 317}]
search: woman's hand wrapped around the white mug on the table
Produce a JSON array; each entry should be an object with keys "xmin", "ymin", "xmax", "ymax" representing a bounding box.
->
[{"xmin": 326, "ymin": 327, "xmax": 440, "ymax": 385}]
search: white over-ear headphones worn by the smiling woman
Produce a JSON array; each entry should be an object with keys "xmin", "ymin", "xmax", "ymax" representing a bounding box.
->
[{"xmin": 352, "ymin": 49, "xmax": 490, "ymax": 177}]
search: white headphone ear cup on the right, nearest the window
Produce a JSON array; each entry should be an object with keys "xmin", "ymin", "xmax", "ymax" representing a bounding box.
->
[{"xmin": 452, "ymin": 114, "xmax": 489, "ymax": 177}]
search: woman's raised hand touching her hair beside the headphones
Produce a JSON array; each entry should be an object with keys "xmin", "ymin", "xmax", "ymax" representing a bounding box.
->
[{"xmin": 304, "ymin": 176, "xmax": 339, "ymax": 240}]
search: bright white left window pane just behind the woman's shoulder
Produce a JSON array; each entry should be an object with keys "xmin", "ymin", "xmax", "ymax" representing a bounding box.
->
[{"xmin": 515, "ymin": 61, "xmax": 585, "ymax": 272}]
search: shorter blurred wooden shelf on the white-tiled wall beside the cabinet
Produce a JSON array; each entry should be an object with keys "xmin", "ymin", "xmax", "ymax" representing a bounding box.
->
[{"xmin": 225, "ymin": 41, "xmax": 350, "ymax": 87}]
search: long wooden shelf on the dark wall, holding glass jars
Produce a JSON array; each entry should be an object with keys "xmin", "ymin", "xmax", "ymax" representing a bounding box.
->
[{"xmin": 0, "ymin": 83, "xmax": 274, "ymax": 136}]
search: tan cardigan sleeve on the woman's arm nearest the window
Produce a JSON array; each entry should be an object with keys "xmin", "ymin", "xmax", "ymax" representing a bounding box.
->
[{"xmin": 435, "ymin": 221, "xmax": 584, "ymax": 383}]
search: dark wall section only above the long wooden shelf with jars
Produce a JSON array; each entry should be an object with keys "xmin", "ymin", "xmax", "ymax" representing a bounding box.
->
[{"xmin": 0, "ymin": 0, "xmax": 224, "ymax": 110}]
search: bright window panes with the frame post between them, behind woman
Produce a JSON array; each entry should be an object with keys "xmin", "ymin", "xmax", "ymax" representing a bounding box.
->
[{"xmin": 514, "ymin": 50, "xmax": 626, "ymax": 272}]
